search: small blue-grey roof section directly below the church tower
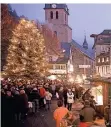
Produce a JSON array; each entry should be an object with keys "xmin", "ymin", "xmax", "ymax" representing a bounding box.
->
[{"xmin": 61, "ymin": 42, "xmax": 71, "ymax": 58}]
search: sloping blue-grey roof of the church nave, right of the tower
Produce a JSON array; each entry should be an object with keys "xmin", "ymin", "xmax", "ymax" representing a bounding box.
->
[{"xmin": 72, "ymin": 40, "xmax": 94, "ymax": 60}]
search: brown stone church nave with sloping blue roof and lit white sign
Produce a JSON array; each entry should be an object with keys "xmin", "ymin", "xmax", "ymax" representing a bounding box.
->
[{"xmin": 71, "ymin": 40, "xmax": 95, "ymax": 83}]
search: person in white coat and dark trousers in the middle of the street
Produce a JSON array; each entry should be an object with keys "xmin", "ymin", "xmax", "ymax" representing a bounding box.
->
[{"xmin": 67, "ymin": 89, "xmax": 74, "ymax": 111}]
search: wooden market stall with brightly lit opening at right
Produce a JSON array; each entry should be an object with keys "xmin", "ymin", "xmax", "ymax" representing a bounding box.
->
[{"xmin": 89, "ymin": 78, "xmax": 111, "ymax": 114}]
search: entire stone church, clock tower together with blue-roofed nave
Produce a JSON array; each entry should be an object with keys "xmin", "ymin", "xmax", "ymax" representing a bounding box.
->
[{"xmin": 44, "ymin": 4, "xmax": 95, "ymax": 82}]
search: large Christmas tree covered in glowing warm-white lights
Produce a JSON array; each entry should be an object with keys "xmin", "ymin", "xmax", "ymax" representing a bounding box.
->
[{"xmin": 4, "ymin": 19, "xmax": 47, "ymax": 78}]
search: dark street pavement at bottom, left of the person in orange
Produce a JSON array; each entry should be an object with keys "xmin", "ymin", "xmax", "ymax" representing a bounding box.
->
[{"xmin": 20, "ymin": 100, "xmax": 57, "ymax": 127}]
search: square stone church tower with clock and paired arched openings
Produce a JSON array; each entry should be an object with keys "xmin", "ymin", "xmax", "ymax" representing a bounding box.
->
[{"xmin": 44, "ymin": 4, "xmax": 72, "ymax": 43}]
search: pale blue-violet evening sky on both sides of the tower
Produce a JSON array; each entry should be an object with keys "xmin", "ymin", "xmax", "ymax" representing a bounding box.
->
[{"xmin": 11, "ymin": 4, "xmax": 111, "ymax": 47}]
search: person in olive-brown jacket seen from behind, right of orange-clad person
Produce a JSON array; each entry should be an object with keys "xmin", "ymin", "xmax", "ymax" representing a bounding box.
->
[{"xmin": 80, "ymin": 100, "xmax": 96, "ymax": 122}]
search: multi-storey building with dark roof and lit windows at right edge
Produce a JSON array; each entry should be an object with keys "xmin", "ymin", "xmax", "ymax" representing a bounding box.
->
[{"xmin": 91, "ymin": 30, "xmax": 111, "ymax": 77}]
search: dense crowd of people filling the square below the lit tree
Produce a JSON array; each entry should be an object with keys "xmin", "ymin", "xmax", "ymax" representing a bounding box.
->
[{"xmin": 1, "ymin": 79, "xmax": 109, "ymax": 127}]
